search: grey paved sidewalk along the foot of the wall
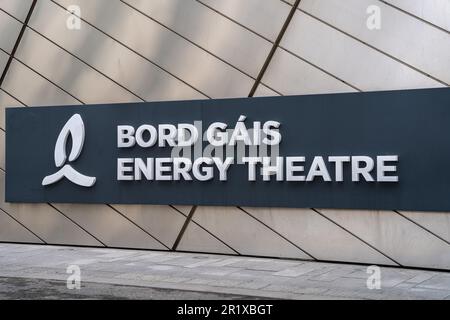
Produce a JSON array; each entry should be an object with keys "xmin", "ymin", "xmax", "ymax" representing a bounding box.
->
[{"xmin": 0, "ymin": 243, "xmax": 450, "ymax": 299}]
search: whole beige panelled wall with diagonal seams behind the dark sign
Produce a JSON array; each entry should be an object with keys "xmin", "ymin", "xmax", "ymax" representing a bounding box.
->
[{"xmin": 0, "ymin": 0, "xmax": 450, "ymax": 269}]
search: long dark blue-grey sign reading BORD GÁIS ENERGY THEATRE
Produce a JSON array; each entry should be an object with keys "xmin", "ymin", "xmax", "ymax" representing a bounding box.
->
[{"xmin": 6, "ymin": 88, "xmax": 450, "ymax": 211}]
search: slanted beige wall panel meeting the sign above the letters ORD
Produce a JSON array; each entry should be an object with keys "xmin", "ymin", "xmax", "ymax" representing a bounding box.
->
[{"xmin": 29, "ymin": 1, "xmax": 205, "ymax": 101}]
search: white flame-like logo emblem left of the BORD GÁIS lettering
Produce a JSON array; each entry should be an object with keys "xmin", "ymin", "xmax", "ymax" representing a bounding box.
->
[{"xmin": 42, "ymin": 114, "xmax": 96, "ymax": 187}]
